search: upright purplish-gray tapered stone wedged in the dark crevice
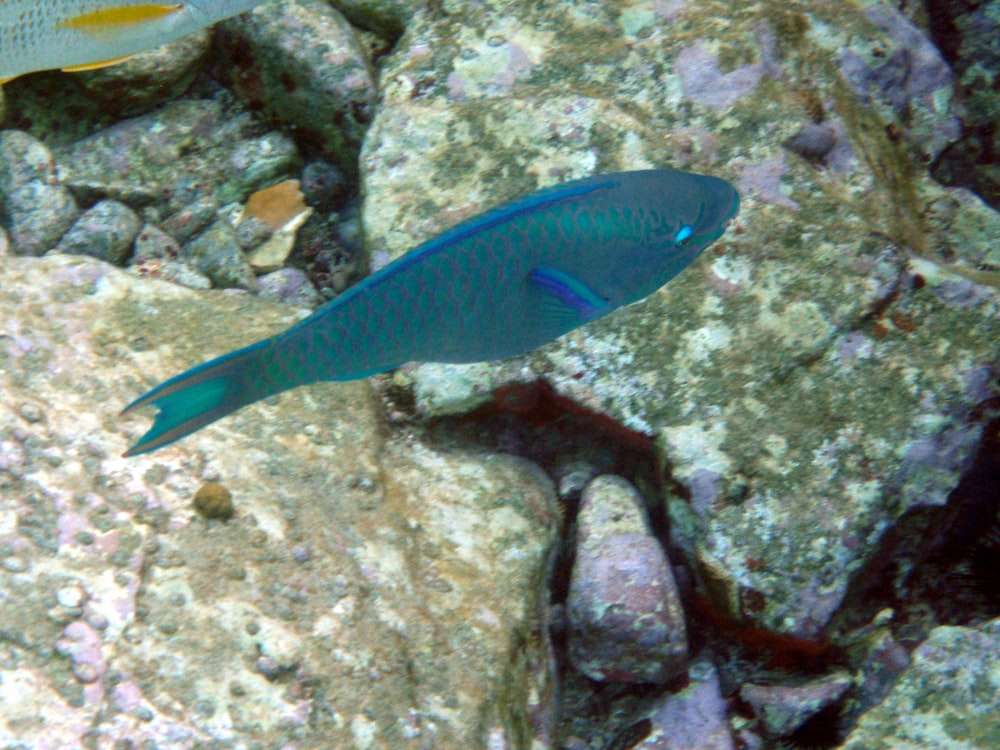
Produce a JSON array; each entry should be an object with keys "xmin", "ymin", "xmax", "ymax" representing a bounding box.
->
[{"xmin": 566, "ymin": 475, "xmax": 687, "ymax": 682}]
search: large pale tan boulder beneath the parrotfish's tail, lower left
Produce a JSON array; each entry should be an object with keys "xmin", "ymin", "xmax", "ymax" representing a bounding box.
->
[{"xmin": 0, "ymin": 255, "xmax": 557, "ymax": 749}]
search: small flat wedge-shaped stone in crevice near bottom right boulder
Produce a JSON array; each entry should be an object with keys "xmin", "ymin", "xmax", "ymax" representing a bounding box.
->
[{"xmin": 740, "ymin": 672, "xmax": 853, "ymax": 737}]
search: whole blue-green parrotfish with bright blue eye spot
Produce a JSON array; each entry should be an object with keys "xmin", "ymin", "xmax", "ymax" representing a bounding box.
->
[{"xmin": 123, "ymin": 169, "xmax": 740, "ymax": 456}]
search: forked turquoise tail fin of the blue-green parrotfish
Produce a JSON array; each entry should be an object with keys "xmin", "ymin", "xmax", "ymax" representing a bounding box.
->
[{"xmin": 122, "ymin": 338, "xmax": 296, "ymax": 456}]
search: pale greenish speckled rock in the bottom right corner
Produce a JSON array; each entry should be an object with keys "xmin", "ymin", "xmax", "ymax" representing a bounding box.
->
[{"xmin": 843, "ymin": 620, "xmax": 1000, "ymax": 750}]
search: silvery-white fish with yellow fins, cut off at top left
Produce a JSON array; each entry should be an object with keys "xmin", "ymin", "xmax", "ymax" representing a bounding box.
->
[{"xmin": 0, "ymin": 0, "xmax": 263, "ymax": 84}]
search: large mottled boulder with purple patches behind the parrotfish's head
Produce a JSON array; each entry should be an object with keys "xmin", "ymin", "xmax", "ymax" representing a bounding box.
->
[{"xmin": 362, "ymin": 2, "xmax": 1000, "ymax": 638}]
